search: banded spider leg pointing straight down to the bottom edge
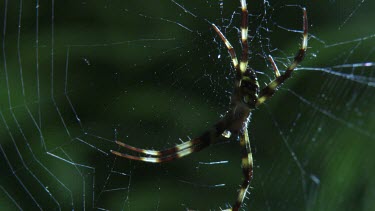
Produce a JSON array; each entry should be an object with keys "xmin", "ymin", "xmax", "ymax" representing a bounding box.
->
[{"xmin": 230, "ymin": 129, "xmax": 253, "ymax": 211}]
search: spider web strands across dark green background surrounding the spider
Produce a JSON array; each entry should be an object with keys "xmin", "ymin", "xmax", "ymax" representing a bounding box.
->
[{"xmin": 0, "ymin": 0, "xmax": 375, "ymax": 210}]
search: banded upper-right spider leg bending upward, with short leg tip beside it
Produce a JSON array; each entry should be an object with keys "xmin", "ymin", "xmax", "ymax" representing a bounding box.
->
[{"xmin": 256, "ymin": 8, "xmax": 308, "ymax": 106}]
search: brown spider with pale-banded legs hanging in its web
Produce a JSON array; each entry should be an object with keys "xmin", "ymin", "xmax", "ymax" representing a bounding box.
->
[{"xmin": 111, "ymin": 0, "xmax": 308, "ymax": 210}]
